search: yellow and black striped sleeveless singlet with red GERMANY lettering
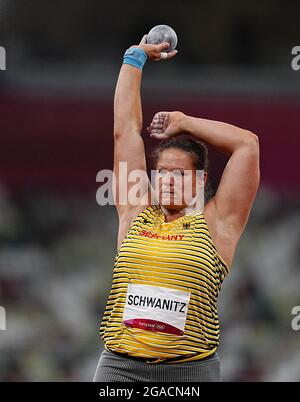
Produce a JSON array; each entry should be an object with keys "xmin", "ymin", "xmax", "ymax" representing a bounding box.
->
[{"xmin": 100, "ymin": 206, "xmax": 228, "ymax": 363}]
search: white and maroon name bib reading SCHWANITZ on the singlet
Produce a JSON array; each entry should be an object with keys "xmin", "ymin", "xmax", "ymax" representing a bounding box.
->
[{"xmin": 123, "ymin": 284, "xmax": 191, "ymax": 335}]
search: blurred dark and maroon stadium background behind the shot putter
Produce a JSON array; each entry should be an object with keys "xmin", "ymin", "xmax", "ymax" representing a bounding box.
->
[{"xmin": 0, "ymin": 0, "xmax": 300, "ymax": 381}]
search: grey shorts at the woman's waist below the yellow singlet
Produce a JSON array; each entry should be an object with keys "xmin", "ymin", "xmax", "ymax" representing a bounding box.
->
[{"xmin": 93, "ymin": 350, "xmax": 221, "ymax": 382}]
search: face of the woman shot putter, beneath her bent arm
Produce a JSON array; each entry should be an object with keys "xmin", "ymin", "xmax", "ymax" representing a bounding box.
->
[{"xmin": 155, "ymin": 148, "xmax": 206, "ymax": 210}]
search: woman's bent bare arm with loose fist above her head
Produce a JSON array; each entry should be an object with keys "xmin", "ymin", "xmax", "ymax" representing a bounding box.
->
[{"xmin": 148, "ymin": 112, "xmax": 260, "ymax": 265}]
